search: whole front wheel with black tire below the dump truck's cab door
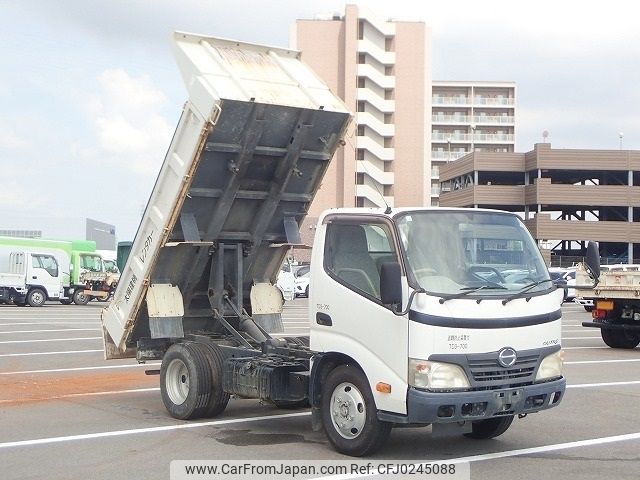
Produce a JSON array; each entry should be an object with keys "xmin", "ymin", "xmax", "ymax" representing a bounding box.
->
[{"xmin": 320, "ymin": 365, "xmax": 392, "ymax": 457}]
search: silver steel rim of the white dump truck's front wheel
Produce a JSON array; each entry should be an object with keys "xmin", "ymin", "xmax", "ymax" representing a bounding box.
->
[{"xmin": 330, "ymin": 382, "xmax": 367, "ymax": 440}]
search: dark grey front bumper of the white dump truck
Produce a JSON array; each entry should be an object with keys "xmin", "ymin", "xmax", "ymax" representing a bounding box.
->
[{"xmin": 378, "ymin": 377, "xmax": 567, "ymax": 424}]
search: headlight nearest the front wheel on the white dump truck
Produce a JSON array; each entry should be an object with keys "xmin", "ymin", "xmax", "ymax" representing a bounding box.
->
[{"xmin": 409, "ymin": 358, "xmax": 470, "ymax": 390}]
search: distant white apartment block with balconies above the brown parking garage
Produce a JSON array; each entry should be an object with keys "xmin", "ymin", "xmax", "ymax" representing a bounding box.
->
[{"xmin": 426, "ymin": 80, "xmax": 516, "ymax": 206}]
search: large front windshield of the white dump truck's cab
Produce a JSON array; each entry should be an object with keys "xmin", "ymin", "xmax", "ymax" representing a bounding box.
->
[{"xmin": 397, "ymin": 210, "xmax": 552, "ymax": 297}]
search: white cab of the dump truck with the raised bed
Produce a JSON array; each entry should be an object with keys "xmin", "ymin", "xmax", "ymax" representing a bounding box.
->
[{"xmin": 309, "ymin": 209, "xmax": 565, "ymax": 452}]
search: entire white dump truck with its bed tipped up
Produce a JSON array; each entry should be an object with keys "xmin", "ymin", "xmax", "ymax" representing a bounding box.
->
[{"xmin": 102, "ymin": 33, "xmax": 565, "ymax": 456}]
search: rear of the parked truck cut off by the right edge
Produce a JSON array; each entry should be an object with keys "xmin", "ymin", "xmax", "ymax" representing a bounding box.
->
[{"xmin": 576, "ymin": 242, "xmax": 640, "ymax": 349}]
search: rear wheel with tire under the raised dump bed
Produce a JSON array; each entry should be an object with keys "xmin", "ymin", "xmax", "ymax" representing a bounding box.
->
[{"xmin": 160, "ymin": 342, "xmax": 211, "ymax": 420}]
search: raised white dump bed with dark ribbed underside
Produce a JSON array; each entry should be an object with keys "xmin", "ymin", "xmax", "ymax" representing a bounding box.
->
[{"xmin": 103, "ymin": 33, "xmax": 350, "ymax": 357}]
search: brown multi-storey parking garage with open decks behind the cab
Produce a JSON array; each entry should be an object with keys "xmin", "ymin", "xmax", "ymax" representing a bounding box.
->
[{"xmin": 440, "ymin": 143, "xmax": 640, "ymax": 263}]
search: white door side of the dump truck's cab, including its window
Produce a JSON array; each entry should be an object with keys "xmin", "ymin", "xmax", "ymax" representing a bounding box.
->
[{"xmin": 309, "ymin": 216, "xmax": 408, "ymax": 413}]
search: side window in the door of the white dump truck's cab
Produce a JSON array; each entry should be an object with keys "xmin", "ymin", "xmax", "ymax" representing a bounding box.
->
[{"xmin": 324, "ymin": 223, "xmax": 397, "ymax": 299}]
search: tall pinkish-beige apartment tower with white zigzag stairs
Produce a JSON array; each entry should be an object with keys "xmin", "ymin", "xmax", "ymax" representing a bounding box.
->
[{"xmin": 291, "ymin": 5, "xmax": 431, "ymax": 218}]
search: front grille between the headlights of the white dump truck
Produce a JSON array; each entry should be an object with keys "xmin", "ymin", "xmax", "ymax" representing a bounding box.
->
[{"xmin": 467, "ymin": 354, "xmax": 540, "ymax": 389}]
